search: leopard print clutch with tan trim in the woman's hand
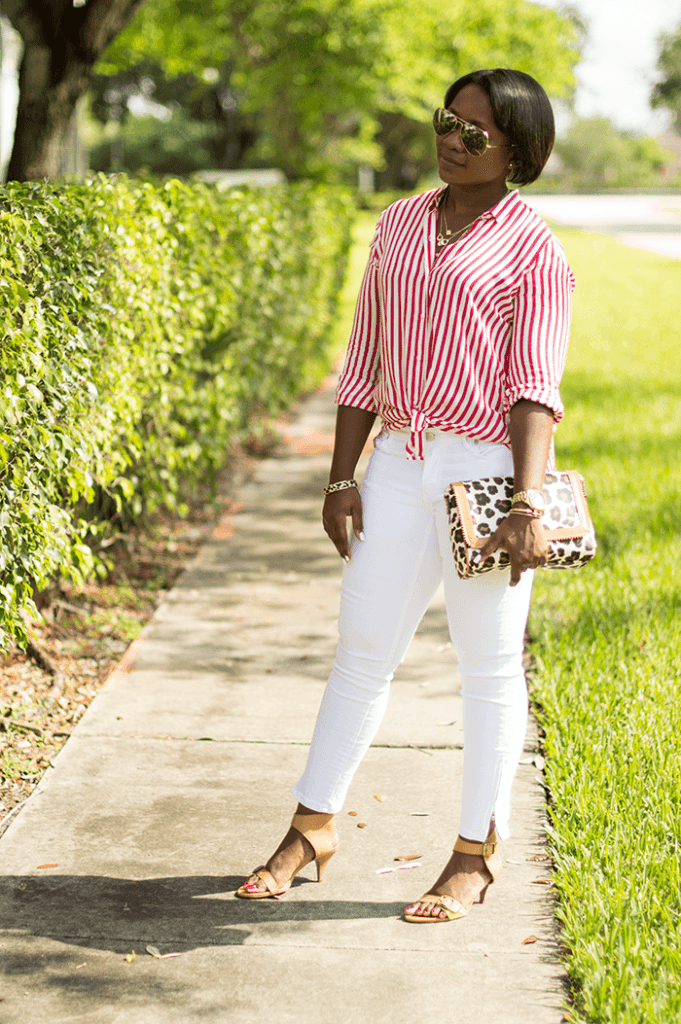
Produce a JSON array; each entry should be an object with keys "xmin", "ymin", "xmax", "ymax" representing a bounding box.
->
[{"xmin": 444, "ymin": 471, "xmax": 596, "ymax": 580}]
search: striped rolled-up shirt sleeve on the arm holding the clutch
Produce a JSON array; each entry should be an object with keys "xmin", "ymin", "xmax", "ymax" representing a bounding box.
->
[{"xmin": 504, "ymin": 239, "xmax": 574, "ymax": 423}]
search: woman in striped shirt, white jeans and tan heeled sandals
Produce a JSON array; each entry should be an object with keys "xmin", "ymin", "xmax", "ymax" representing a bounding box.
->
[{"xmin": 237, "ymin": 69, "xmax": 573, "ymax": 924}]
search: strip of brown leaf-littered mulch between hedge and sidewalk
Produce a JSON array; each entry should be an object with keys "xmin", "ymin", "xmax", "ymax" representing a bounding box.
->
[{"xmin": 0, "ymin": 503, "xmax": 228, "ymax": 835}]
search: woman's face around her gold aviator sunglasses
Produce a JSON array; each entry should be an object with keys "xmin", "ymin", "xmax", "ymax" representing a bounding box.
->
[{"xmin": 435, "ymin": 84, "xmax": 511, "ymax": 185}]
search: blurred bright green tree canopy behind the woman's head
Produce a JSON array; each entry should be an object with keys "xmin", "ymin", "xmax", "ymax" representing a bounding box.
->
[{"xmin": 95, "ymin": 0, "xmax": 580, "ymax": 183}]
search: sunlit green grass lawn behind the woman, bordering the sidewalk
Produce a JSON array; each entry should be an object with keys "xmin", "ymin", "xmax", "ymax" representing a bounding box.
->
[{"xmin": 337, "ymin": 214, "xmax": 681, "ymax": 1024}]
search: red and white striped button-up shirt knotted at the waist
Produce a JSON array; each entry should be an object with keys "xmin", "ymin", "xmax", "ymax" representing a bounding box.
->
[{"xmin": 336, "ymin": 188, "xmax": 574, "ymax": 459}]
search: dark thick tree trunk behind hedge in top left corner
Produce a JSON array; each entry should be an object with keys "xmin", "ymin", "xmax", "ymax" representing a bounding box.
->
[{"xmin": 2, "ymin": 0, "xmax": 148, "ymax": 181}]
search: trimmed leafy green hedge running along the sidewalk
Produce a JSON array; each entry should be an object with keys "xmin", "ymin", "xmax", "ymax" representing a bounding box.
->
[{"xmin": 0, "ymin": 177, "xmax": 353, "ymax": 646}]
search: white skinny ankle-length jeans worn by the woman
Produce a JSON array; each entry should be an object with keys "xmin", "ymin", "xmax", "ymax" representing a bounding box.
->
[{"xmin": 293, "ymin": 431, "xmax": 533, "ymax": 841}]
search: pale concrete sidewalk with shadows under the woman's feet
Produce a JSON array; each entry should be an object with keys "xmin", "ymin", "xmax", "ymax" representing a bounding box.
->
[{"xmin": 0, "ymin": 376, "xmax": 564, "ymax": 1024}]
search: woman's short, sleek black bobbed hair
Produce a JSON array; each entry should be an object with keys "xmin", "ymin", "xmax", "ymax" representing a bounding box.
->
[{"xmin": 444, "ymin": 68, "xmax": 556, "ymax": 185}]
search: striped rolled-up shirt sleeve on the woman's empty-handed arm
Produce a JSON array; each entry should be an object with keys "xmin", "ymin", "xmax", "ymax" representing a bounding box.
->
[{"xmin": 336, "ymin": 214, "xmax": 383, "ymax": 413}]
